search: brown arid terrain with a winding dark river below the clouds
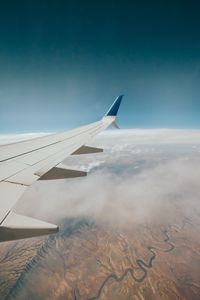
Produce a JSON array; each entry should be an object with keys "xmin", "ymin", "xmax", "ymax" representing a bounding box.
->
[{"xmin": 0, "ymin": 209, "xmax": 200, "ymax": 300}]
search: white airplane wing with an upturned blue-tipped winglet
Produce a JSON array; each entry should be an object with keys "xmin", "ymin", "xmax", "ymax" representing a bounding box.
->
[{"xmin": 0, "ymin": 95, "xmax": 123, "ymax": 242}]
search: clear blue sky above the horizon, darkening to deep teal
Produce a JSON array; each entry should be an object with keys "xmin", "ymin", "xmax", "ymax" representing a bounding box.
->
[{"xmin": 0, "ymin": 0, "xmax": 200, "ymax": 134}]
